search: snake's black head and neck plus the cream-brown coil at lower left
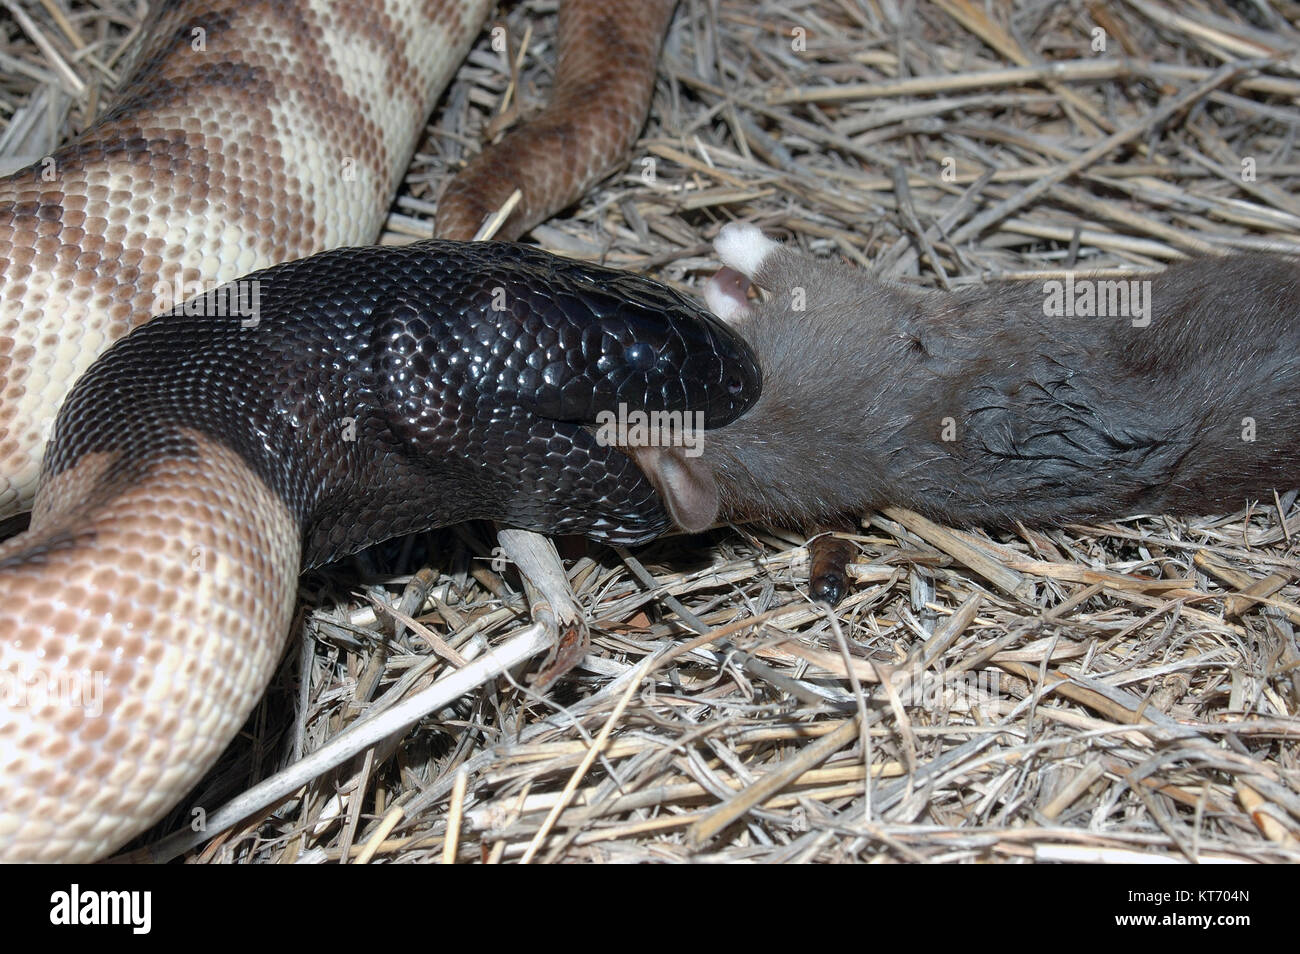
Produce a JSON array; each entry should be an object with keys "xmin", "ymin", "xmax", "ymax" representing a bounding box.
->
[{"xmin": 0, "ymin": 240, "xmax": 759, "ymax": 858}]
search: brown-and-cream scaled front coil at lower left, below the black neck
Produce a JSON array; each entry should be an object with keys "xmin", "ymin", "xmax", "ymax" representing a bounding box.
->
[{"xmin": 0, "ymin": 433, "xmax": 300, "ymax": 862}]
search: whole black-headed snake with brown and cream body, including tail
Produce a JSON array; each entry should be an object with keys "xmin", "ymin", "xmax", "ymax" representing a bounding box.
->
[{"xmin": 0, "ymin": 0, "xmax": 758, "ymax": 860}]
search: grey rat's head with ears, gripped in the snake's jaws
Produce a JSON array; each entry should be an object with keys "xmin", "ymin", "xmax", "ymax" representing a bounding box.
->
[{"xmin": 631, "ymin": 224, "xmax": 919, "ymax": 532}]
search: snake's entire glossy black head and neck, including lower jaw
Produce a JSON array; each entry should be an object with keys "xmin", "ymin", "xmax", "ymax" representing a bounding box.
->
[{"xmin": 46, "ymin": 240, "xmax": 761, "ymax": 565}]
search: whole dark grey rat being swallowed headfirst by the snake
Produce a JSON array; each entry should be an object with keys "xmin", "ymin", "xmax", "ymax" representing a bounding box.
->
[{"xmin": 627, "ymin": 224, "xmax": 1300, "ymax": 556}]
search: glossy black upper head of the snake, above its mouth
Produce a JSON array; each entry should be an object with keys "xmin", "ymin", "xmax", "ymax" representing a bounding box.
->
[{"xmin": 376, "ymin": 242, "xmax": 762, "ymax": 428}]
